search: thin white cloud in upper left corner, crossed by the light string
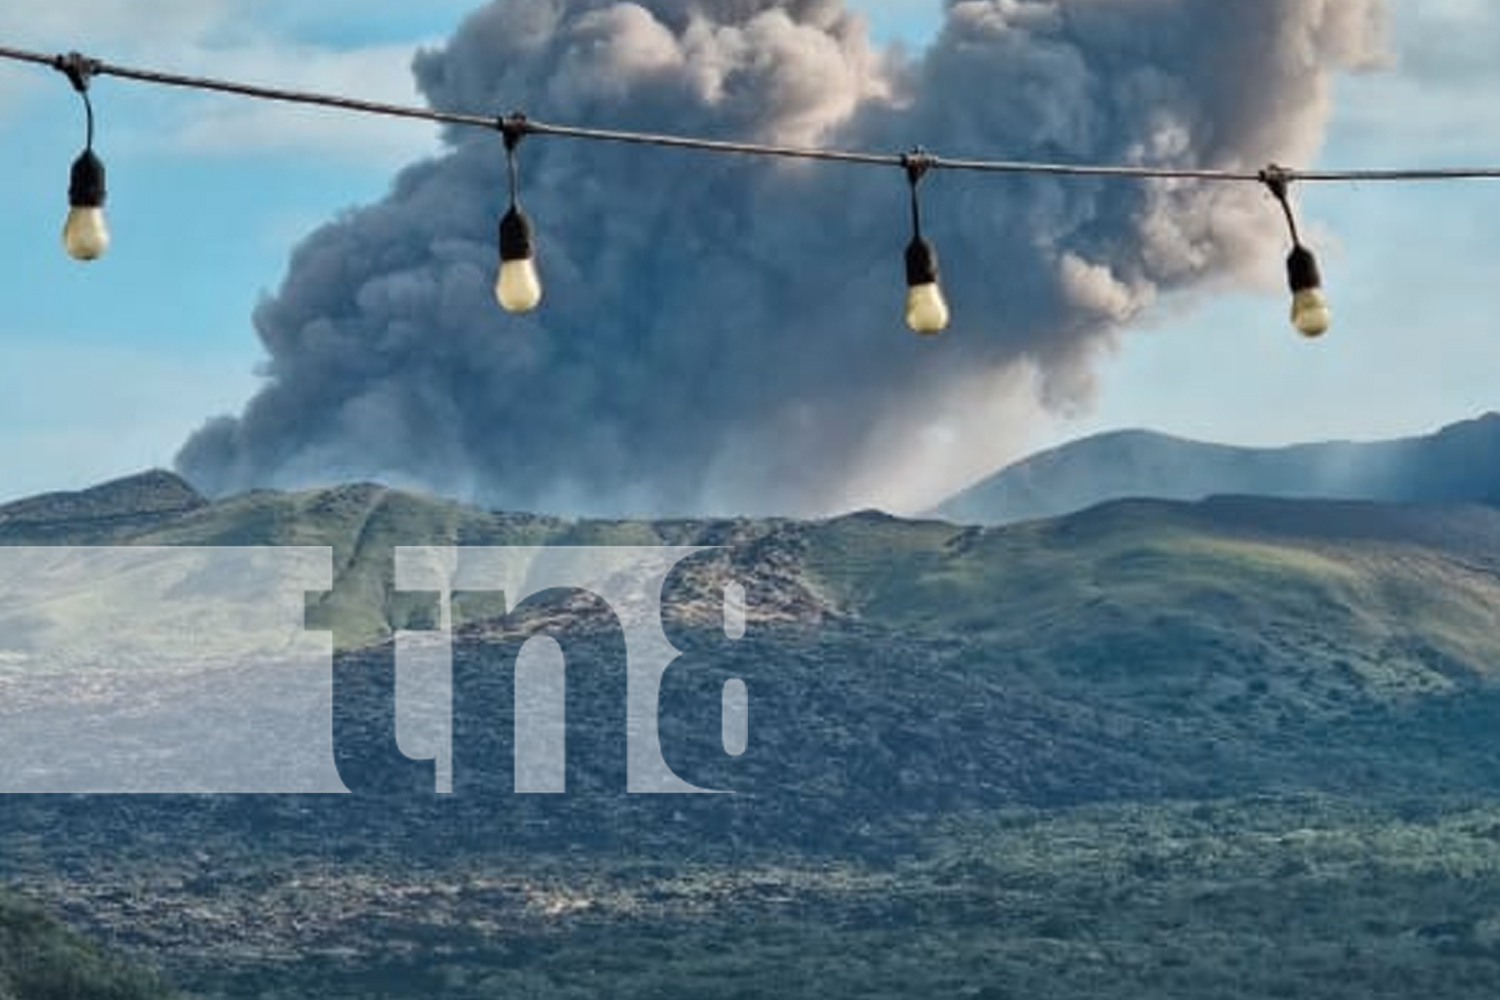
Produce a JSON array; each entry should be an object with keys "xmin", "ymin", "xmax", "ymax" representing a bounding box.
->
[{"xmin": 0, "ymin": 0, "xmax": 456, "ymax": 168}]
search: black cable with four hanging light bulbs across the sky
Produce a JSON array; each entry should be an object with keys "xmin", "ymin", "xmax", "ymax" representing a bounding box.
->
[{"xmin": 0, "ymin": 46, "xmax": 1500, "ymax": 337}]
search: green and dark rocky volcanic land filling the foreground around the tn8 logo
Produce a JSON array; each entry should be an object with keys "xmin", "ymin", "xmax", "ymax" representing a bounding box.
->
[{"xmin": 0, "ymin": 481, "xmax": 1500, "ymax": 1000}]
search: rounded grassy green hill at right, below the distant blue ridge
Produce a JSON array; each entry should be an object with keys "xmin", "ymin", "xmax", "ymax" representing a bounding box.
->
[{"xmin": 806, "ymin": 498, "xmax": 1500, "ymax": 709}]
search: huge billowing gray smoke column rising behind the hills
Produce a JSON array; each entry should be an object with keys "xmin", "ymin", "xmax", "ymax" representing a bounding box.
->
[{"xmin": 179, "ymin": 0, "xmax": 1382, "ymax": 514}]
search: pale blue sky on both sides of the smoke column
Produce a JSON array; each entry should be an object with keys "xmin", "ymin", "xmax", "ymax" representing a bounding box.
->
[{"xmin": 0, "ymin": 0, "xmax": 1500, "ymax": 509}]
